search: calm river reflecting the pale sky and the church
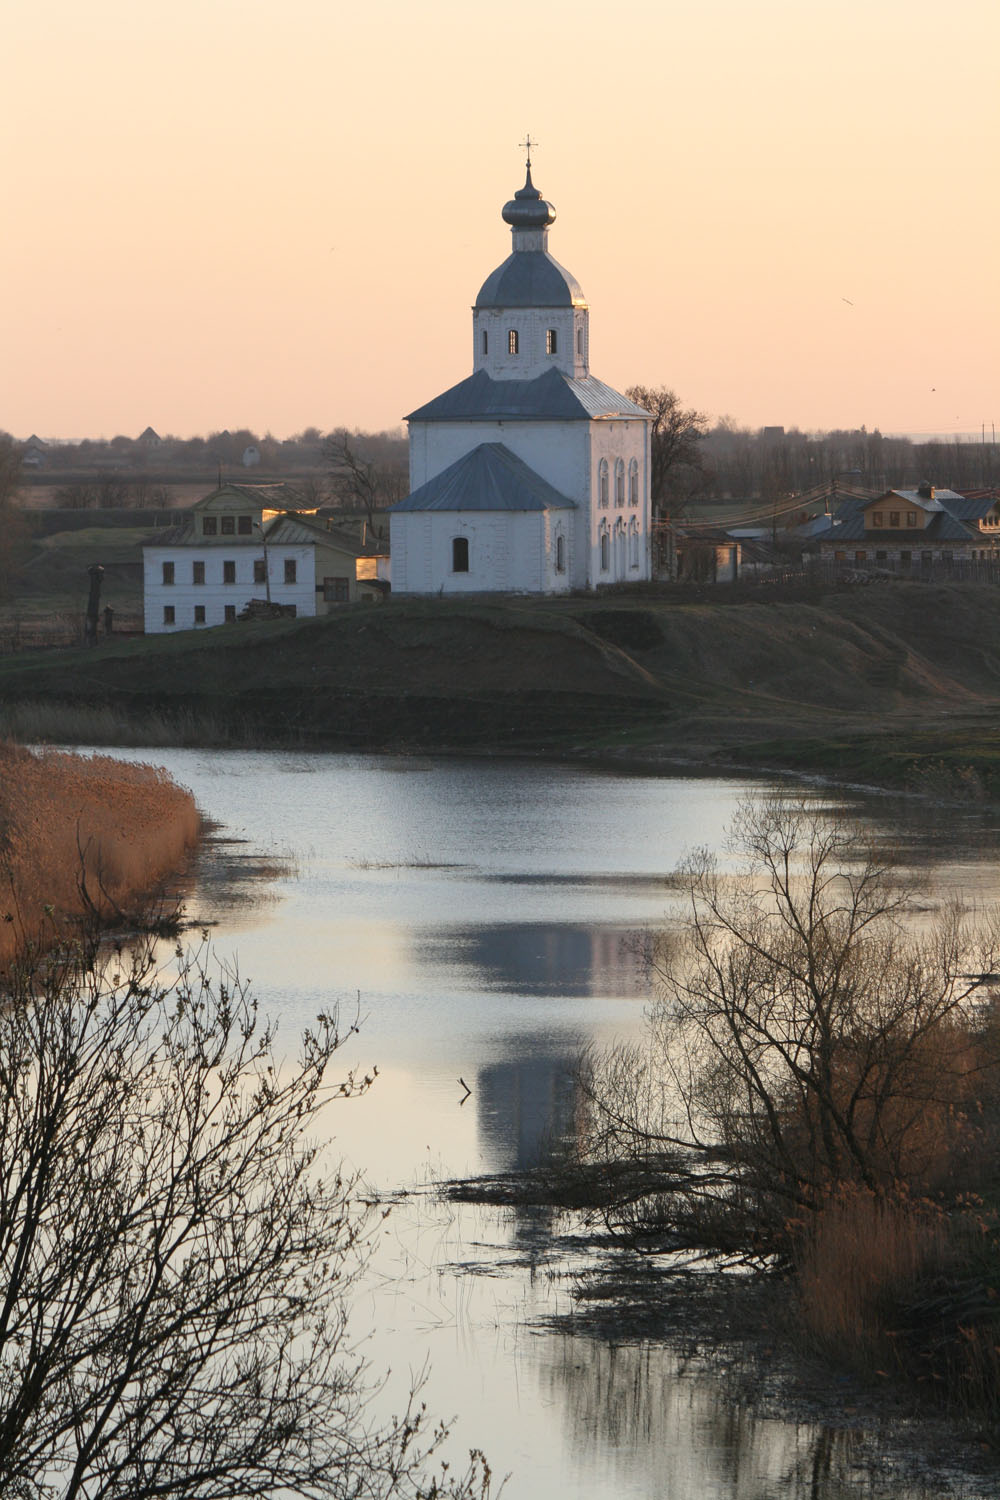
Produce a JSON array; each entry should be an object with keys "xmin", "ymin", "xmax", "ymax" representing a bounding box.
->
[{"xmin": 88, "ymin": 750, "xmax": 1000, "ymax": 1500}]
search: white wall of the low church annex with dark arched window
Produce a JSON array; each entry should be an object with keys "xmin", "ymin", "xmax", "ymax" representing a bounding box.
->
[{"xmin": 390, "ymin": 510, "xmax": 576, "ymax": 594}]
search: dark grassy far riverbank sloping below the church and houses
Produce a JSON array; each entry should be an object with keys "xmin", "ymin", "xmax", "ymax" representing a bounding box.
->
[{"xmin": 0, "ymin": 584, "xmax": 1000, "ymax": 798}]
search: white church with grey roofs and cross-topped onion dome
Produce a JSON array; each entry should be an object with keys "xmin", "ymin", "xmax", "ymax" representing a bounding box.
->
[{"xmin": 390, "ymin": 156, "xmax": 652, "ymax": 594}]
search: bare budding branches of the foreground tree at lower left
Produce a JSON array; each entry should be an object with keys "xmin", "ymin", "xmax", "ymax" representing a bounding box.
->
[{"xmin": 0, "ymin": 947, "xmax": 489, "ymax": 1500}]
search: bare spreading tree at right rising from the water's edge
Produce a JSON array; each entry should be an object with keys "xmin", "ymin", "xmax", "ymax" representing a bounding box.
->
[{"xmin": 589, "ymin": 803, "xmax": 1000, "ymax": 1253}]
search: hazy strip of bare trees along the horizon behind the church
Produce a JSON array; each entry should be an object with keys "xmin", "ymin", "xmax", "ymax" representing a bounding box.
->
[{"xmin": 0, "ymin": 402, "xmax": 1000, "ymax": 518}]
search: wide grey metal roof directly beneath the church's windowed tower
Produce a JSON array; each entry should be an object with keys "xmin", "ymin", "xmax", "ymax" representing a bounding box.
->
[{"xmin": 406, "ymin": 369, "xmax": 652, "ymax": 422}]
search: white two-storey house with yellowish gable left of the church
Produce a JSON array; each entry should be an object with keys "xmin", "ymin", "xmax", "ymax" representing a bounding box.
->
[{"xmin": 142, "ymin": 485, "xmax": 384, "ymax": 635}]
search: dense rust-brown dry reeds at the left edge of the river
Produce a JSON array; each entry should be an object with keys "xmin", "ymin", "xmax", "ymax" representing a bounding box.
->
[{"xmin": 0, "ymin": 743, "xmax": 201, "ymax": 965}]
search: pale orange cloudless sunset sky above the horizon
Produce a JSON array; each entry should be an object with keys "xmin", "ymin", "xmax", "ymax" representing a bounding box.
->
[{"xmin": 0, "ymin": 0, "xmax": 1000, "ymax": 438}]
